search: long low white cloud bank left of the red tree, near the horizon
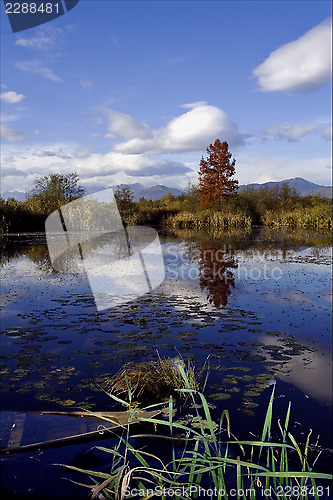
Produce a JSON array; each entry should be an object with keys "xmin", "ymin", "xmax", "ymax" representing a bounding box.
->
[{"xmin": 3, "ymin": 144, "xmax": 192, "ymax": 190}]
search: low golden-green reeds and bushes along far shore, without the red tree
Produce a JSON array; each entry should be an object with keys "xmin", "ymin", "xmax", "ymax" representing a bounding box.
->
[{"xmin": 0, "ymin": 184, "xmax": 332, "ymax": 234}]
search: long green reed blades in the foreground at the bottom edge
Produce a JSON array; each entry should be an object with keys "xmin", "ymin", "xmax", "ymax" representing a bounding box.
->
[{"xmin": 65, "ymin": 364, "xmax": 333, "ymax": 500}]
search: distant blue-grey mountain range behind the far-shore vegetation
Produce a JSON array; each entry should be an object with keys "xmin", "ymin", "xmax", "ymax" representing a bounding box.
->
[{"xmin": 2, "ymin": 177, "xmax": 332, "ymax": 201}]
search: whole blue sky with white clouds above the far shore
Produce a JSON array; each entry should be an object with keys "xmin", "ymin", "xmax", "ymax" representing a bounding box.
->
[{"xmin": 0, "ymin": 0, "xmax": 332, "ymax": 197}]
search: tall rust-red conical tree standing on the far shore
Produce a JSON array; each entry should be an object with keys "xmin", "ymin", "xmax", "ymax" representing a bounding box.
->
[{"xmin": 198, "ymin": 139, "xmax": 238, "ymax": 208}]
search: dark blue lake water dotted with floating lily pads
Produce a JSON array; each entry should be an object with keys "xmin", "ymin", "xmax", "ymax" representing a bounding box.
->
[{"xmin": 0, "ymin": 228, "xmax": 332, "ymax": 498}]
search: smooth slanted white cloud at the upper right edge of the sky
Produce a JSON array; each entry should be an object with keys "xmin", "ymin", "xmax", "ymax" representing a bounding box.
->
[{"xmin": 253, "ymin": 20, "xmax": 331, "ymax": 92}]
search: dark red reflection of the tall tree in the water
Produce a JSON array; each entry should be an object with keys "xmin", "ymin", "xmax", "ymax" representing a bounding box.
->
[{"xmin": 199, "ymin": 241, "xmax": 237, "ymax": 307}]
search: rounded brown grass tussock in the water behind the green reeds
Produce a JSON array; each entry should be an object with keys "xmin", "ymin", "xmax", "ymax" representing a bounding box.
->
[{"xmin": 104, "ymin": 357, "xmax": 198, "ymax": 403}]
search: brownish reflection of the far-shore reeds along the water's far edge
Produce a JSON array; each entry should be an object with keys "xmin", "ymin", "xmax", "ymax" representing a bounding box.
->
[{"xmin": 0, "ymin": 227, "xmax": 332, "ymax": 272}]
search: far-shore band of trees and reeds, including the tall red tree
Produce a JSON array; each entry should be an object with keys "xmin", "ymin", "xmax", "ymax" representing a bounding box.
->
[{"xmin": 0, "ymin": 139, "xmax": 332, "ymax": 233}]
